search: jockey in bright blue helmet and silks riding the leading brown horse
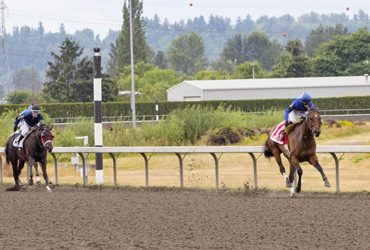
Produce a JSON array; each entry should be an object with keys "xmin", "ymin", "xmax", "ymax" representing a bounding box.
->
[{"xmin": 281, "ymin": 92, "xmax": 315, "ymax": 138}]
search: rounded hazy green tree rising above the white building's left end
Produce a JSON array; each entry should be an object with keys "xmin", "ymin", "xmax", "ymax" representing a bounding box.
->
[{"xmin": 167, "ymin": 32, "xmax": 207, "ymax": 74}]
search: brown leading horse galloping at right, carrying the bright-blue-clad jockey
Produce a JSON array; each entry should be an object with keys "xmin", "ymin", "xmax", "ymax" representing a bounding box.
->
[{"xmin": 264, "ymin": 110, "xmax": 330, "ymax": 196}]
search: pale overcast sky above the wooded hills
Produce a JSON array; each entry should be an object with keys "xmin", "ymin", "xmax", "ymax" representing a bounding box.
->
[{"xmin": 4, "ymin": 0, "xmax": 370, "ymax": 38}]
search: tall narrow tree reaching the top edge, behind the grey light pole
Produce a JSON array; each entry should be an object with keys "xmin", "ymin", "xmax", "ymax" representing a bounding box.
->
[{"xmin": 115, "ymin": 0, "xmax": 152, "ymax": 72}]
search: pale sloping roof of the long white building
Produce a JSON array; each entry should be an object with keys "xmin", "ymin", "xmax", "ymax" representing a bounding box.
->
[{"xmin": 167, "ymin": 76, "xmax": 370, "ymax": 91}]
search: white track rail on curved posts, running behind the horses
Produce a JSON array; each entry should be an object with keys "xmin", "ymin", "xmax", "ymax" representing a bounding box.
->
[{"xmin": 0, "ymin": 145, "xmax": 370, "ymax": 192}]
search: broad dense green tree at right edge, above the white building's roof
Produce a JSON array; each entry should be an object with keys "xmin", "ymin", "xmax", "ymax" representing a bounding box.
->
[{"xmin": 313, "ymin": 28, "xmax": 370, "ymax": 76}]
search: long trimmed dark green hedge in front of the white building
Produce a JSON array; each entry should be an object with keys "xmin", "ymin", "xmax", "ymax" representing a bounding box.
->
[{"xmin": 0, "ymin": 96, "xmax": 370, "ymax": 118}]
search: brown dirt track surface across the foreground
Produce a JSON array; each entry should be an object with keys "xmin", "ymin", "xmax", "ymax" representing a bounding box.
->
[{"xmin": 0, "ymin": 186, "xmax": 370, "ymax": 249}]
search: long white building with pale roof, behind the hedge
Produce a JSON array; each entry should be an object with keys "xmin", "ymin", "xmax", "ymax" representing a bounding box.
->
[{"xmin": 167, "ymin": 75, "xmax": 370, "ymax": 101}]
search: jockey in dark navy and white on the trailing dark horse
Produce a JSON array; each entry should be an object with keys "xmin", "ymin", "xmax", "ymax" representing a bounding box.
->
[{"xmin": 14, "ymin": 105, "xmax": 44, "ymax": 145}]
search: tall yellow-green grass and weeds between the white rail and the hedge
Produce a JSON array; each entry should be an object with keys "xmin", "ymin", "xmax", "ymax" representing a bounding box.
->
[{"xmin": 47, "ymin": 106, "xmax": 282, "ymax": 146}]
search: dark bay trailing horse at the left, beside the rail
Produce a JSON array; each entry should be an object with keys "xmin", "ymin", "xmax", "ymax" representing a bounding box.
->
[{"xmin": 5, "ymin": 124, "xmax": 54, "ymax": 191}]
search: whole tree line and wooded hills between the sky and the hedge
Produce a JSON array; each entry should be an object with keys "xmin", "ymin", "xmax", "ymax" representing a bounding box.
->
[{"xmin": 0, "ymin": 0, "xmax": 370, "ymax": 103}]
